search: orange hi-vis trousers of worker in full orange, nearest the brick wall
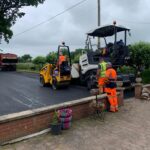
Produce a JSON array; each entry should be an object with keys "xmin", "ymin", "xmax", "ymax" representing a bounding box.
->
[{"xmin": 105, "ymin": 88, "xmax": 118, "ymax": 112}]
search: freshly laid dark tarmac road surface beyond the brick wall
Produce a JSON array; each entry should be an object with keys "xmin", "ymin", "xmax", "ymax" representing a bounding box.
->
[{"xmin": 0, "ymin": 72, "xmax": 90, "ymax": 115}]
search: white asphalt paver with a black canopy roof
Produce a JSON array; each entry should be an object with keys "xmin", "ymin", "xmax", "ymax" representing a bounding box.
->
[{"xmin": 72, "ymin": 23, "xmax": 135, "ymax": 89}]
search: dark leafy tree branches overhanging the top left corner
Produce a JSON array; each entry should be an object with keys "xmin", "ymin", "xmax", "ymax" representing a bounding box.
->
[{"xmin": 0, "ymin": 0, "xmax": 45, "ymax": 42}]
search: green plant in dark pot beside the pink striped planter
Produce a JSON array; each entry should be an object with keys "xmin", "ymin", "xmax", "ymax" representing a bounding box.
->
[{"xmin": 51, "ymin": 110, "xmax": 61, "ymax": 135}]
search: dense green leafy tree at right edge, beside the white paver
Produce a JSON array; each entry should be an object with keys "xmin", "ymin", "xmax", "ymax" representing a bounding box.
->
[{"xmin": 129, "ymin": 42, "xmax": 150, "ymax": 71}]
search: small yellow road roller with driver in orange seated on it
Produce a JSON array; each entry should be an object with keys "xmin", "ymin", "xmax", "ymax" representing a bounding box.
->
[{"xmin": 40, "ymin": 42, "xmax": 71, "ymax": 90}]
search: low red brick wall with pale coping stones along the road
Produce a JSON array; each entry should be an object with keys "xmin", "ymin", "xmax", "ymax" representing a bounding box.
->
[{"xmin": 0, "ymin": 94, "xmax": 123, "ymax": 144}]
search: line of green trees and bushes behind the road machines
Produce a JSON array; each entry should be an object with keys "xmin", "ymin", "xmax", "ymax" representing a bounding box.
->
[{"xmin": 19, "ymin": 42, "xmax": 150, "ymax": 71}]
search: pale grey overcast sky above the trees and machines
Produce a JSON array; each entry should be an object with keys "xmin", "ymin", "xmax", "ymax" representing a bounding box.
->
[{"xmin": 0, "ymin": 0, "xmax": 150, "ymax": 57}]
